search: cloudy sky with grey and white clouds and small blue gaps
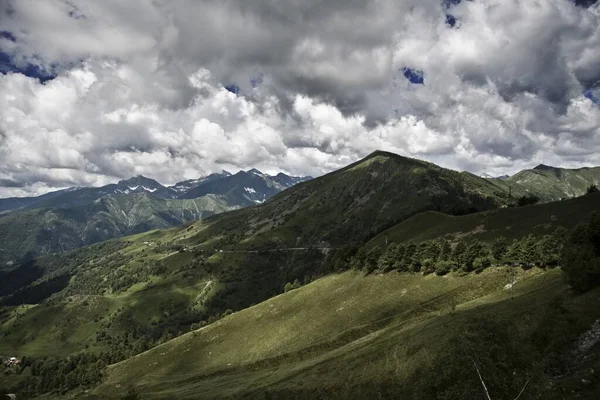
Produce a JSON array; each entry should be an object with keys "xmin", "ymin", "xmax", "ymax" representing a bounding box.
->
[{"xmin": 0, "ymin": 0, "xmax": 600, "ymax": 197}]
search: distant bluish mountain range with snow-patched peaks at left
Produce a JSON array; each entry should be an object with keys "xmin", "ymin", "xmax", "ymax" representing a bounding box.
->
[{"xmin": 0, "ymin": 169, "xmax": 311, "ymax": 268}]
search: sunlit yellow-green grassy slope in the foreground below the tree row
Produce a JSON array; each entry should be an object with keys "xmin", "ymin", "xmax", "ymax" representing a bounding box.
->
[{"xmin": 88, "ymin": 269, "xmax": 598, "ymax": 399}]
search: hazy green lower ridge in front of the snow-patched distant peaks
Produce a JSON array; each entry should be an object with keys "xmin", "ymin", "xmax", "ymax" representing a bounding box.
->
[{"xmin": 0, "ymin": 193, "xmax": 235, "ymax": 267}]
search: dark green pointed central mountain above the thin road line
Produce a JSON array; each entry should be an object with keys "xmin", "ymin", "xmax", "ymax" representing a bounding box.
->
[{"xmin": 182, "ymin": 152, "xmax": 508, "ymax": 247}]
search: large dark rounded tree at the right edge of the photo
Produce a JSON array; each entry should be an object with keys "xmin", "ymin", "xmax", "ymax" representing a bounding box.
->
[{"xmin": 561, "ymin": 214, "xmax": 600, "ymax": 292}]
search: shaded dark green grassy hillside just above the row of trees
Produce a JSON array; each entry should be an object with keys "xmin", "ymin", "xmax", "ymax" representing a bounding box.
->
[{"xmin": 370, "ymin": 193, "xmax": 600, "ymax": 245}]
